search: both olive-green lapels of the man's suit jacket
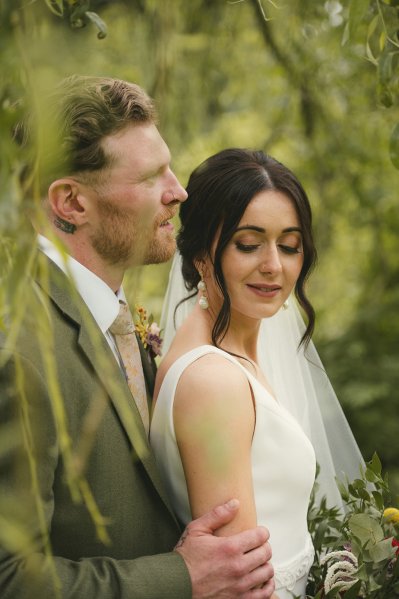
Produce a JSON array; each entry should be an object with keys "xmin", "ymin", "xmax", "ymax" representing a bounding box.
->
[{"xmin": 38, "ymin": 259, "xmax": 180, "ymax": 519}]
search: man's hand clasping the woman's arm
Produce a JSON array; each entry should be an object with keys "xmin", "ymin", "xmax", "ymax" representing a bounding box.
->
[{"xmin": 175, "ymin": 499, "xmax": 274, "ymax": 599}]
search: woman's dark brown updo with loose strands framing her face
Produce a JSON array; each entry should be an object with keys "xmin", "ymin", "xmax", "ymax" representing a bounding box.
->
[{"xmin": 177, "ymin": 148, "xmax": 316, "ymax": 346}]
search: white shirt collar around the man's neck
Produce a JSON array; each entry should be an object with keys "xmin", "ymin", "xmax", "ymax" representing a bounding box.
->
[{"xmin": 38, "ymin": 235, "xmax": 126, "ymax": 333}]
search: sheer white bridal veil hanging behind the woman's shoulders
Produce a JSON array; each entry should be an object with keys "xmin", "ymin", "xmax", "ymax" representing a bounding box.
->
[{"xmin": 161, "ymin": 253, "xmax": 364, "ymax": 507}]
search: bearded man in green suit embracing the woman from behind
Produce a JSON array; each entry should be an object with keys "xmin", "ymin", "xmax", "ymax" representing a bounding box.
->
[{"xmin": 0, "ymin": 77, "xmax": 274, "ymax": 599}]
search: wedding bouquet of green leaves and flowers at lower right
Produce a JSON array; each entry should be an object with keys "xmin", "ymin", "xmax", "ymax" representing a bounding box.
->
[{"xmin": 306, "ymin": 454, "xmax": 399, "ymax": 599}]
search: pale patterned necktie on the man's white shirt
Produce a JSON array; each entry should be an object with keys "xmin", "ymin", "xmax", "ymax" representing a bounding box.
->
[{"xmin": 109, "ymin": 300, "xmax": 150, "ymax": 435}]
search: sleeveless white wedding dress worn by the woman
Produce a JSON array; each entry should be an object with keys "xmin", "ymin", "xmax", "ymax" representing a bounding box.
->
[{"xmin": 150, "ymin": 345, "xmax": 316, "ymax": 599}]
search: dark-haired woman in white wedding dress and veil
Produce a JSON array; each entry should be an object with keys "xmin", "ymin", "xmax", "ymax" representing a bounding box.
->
[{"xmin": 150, "ymin": 149, "xmax": 362, "ymax": 599}]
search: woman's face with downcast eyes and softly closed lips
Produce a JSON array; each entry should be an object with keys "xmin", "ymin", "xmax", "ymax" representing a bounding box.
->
[{"xmin": 211, "ymin": 190, "xmax": 303, "ymax": 319}]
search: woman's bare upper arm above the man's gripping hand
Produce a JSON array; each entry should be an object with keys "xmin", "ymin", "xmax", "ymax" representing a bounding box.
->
[{"xmin": 174, "ymin": 354, "xmax": 257, "ymax": 535}]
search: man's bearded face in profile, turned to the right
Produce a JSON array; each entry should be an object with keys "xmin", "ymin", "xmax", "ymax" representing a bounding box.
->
[{"xmin": 90, "ymin": 123, "xmax": 187, "ymax": 267}]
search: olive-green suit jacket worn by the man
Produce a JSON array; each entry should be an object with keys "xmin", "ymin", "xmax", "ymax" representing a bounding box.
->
[{"xmin": 0, "ymin": 256, "xmax": 191, "ymax": 599}]
